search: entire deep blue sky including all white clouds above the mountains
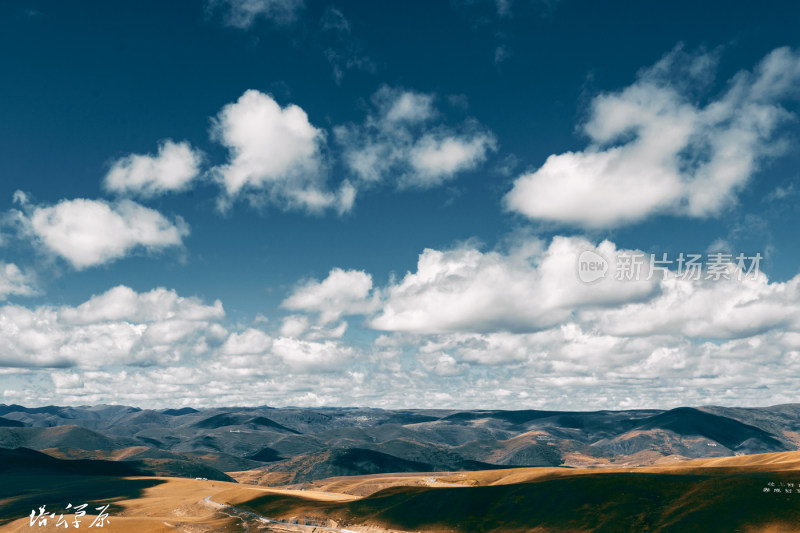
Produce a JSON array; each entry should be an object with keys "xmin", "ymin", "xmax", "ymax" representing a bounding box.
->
[{"xmin": 0, "ymin": 0, "xmax": 800, "ymax": 409}]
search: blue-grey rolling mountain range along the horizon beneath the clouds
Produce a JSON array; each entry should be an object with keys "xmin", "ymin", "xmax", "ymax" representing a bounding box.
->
[{"xmin": 0, "ymin": 404, "xmax": 800, "ymax": 481}]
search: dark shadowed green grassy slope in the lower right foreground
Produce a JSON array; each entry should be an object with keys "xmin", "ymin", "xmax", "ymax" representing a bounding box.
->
[{"xmin": 237, "ymin": 456, "xmax": 800, "ymax": 533}]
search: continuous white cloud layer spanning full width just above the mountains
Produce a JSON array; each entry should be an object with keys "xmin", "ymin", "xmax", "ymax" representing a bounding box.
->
[{"xmin": 0, "ymin": 237, "xmax": 800, "ymax": 409}]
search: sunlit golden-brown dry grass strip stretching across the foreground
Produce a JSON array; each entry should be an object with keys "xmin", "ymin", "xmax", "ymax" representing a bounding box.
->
[{"xmin": 9, "ymin": 452, "xmax": 800, "ymax": 533}]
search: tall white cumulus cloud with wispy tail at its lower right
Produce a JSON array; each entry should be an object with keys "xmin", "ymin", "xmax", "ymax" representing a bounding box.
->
[{"xmin": 212, "ymin": 90, "xmax": 352, "ymax": 212}]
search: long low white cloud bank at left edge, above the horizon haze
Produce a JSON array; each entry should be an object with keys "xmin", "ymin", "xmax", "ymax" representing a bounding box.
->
[{"xmin": 0, "ymin": 286, "xmax": 227, "ymax": 367}]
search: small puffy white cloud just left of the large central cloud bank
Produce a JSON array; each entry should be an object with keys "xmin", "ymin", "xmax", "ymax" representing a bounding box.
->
[{"xmin": 281, "ymin": 268, "xmax": 377, "ymax": 327}]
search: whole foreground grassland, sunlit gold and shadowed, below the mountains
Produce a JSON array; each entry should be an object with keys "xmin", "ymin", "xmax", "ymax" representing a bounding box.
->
[{"xmin": 0, "ymin": 452, "xmax": 800, "ymax": 533}]
